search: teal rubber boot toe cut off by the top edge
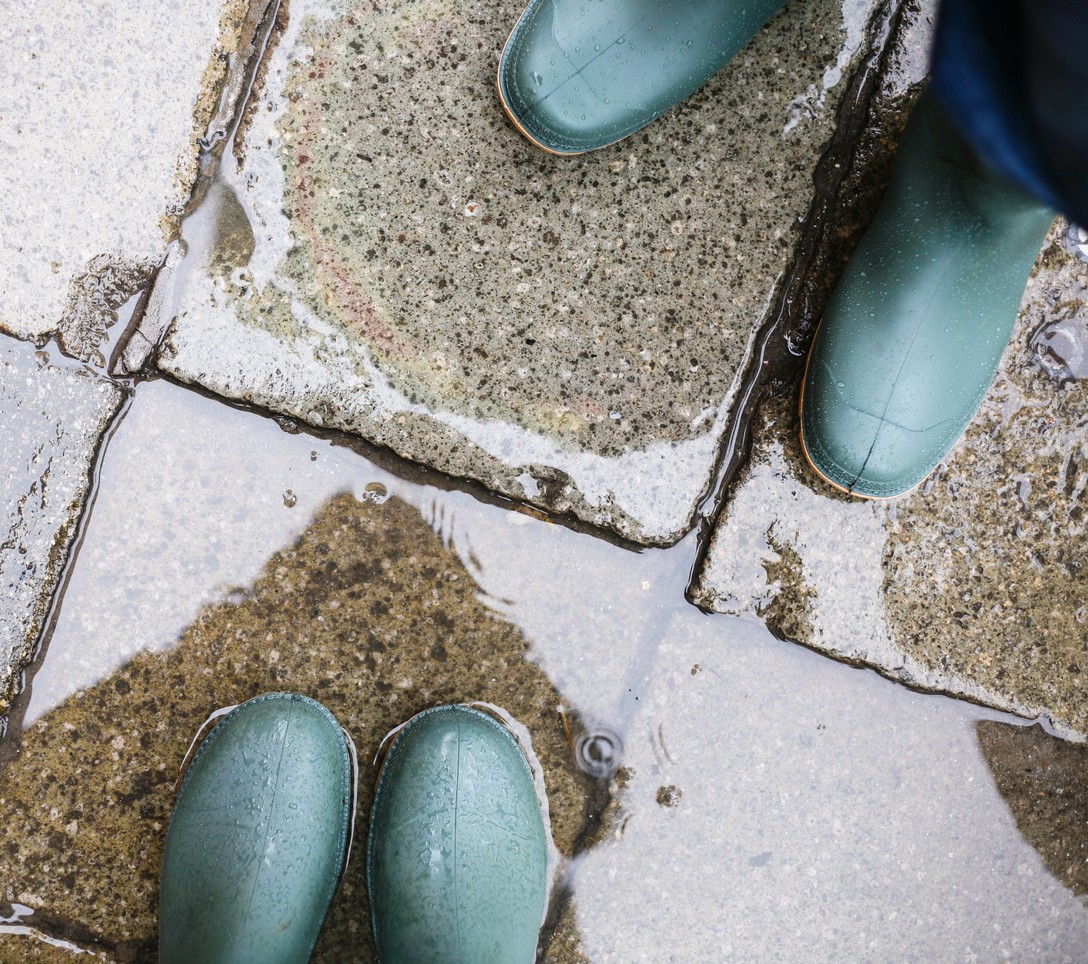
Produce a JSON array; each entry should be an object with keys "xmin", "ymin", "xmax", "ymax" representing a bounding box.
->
[{"xmin": 498, "ymin": 0, "xmax": 784, "ymax": 155}]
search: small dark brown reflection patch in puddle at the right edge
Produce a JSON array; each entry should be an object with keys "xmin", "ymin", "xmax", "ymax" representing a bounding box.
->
[{"xmin": 976, "ymin": 720, "xmax": 1088, "ymax": 895}]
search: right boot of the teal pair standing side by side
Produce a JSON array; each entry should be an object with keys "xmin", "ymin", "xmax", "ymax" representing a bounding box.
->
[{"xmin": 367, "ymin": 706, "xmax": 547, "ymax": 964}]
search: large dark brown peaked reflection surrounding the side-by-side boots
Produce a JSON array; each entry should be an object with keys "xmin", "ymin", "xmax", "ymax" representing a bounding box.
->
[{"xmin": 0, "ymin": 493, "xmax": 590, "ymax": 961}]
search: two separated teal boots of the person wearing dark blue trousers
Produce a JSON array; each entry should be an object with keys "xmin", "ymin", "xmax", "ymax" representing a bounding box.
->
[{"xmin": 498, "ymin": 0, "xmax": 1055, "ymax": 498}]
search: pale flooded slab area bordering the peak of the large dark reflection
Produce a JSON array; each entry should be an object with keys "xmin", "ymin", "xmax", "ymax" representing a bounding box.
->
[{"xmin": 24, "ymin": 382, "xmax": 689, "ymax": 736}]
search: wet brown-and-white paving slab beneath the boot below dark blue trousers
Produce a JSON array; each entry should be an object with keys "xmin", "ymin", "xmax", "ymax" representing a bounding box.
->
[{"xmin": 693, "ymin": 222, "xmax": 1088, "ymax": 739}]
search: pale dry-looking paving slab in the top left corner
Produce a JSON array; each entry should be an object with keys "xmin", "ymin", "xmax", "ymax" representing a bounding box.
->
[{"xmin": 0, "ymin": 0, "xmax": 246, "ymax": 358}]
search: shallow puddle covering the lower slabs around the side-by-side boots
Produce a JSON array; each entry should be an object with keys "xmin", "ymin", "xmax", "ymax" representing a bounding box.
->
[{"xmin": 0, "ymin": 381, "xmax": 1088, "ymax": 962}]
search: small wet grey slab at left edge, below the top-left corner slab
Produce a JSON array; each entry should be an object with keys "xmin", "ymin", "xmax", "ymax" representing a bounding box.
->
[{"xmin": 0, "ymin": 336, "xmax": 125, "ymax": 713}]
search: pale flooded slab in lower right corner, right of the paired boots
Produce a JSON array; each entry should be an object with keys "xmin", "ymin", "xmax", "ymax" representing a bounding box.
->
[{"xmin": 574, "ymin": 616, "xmax": 1088, "ymax": 962}]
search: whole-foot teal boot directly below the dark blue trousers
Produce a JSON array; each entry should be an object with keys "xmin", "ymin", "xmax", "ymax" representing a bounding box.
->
[{"xmin": 801, "ymin": 95, "xmax": 1055, "ymax": 498}]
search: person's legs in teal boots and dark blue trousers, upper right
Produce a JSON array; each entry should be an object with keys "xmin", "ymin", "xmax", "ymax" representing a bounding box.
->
[{"xmin": 498, "ymin": 0, "xmax": 1088, "ymax": 497}]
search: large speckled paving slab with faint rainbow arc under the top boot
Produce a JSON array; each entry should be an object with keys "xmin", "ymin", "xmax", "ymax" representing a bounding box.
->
[{"xmin": 142, "ymin": 0, "xmax": 890, "ymax": 544}]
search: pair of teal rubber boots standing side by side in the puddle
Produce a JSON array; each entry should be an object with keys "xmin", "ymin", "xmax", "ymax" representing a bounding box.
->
[{"xmin": 159, "ymin": 693, "xmax": 548, "ymax": 964}]
